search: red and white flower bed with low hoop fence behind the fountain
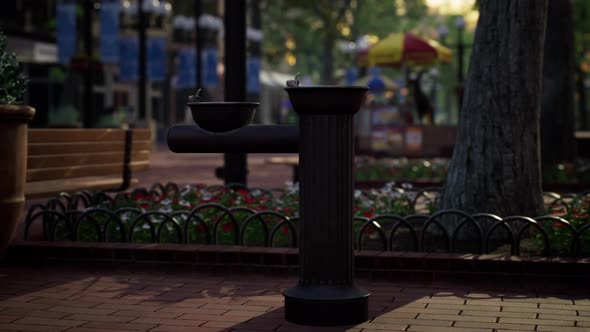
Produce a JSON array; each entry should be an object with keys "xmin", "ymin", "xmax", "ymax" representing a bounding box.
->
[{"xmin": 27, "ymin": 184, "xmax": 590, "ymax": 256}]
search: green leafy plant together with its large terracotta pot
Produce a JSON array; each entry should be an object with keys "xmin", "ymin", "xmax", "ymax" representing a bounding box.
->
[{"xmin": 0, "ymin": 32, "xmax": 35, "ymax": 257}]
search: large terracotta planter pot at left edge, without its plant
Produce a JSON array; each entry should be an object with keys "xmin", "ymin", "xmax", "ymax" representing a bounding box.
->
[{"xmin": 0, "ymin": 105, "xmax": 35, "ymax": 257}]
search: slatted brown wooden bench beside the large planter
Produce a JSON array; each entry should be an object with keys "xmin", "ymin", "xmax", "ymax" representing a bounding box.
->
[{"xmin": 25, "ymin": 129, "xmax": 152, "ymax": 199}]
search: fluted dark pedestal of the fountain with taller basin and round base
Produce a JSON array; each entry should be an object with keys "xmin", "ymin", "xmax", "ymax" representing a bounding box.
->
[{"xmin": 284, "ymin": 87, "xmax": 369, "ymax": 325}]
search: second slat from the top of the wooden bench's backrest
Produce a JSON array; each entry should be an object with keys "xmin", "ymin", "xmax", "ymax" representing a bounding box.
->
[{"xmin": 28, "ymin": 141, "xmax": 151, "ymax": 156}]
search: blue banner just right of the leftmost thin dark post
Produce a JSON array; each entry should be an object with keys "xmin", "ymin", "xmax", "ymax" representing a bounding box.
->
[{"xmin": 100, "ymin": 1, "xmax": 121, "ymax": 63}]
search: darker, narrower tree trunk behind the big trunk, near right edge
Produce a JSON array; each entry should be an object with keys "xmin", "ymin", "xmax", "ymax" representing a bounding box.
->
[{"xmin": 541, "ymin": 0, "xmax": 576, "ymax": 164}]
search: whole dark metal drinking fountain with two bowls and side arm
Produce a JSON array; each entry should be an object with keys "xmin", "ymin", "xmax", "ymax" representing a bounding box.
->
[{"xmin": 168, "ymin": 79, "xmax": 370, "ymax": 326}]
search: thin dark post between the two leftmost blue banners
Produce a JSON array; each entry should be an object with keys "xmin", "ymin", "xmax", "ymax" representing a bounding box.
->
[{"xmin": 82, "ymin": 0, "xmax": 95, "ymax": 128}]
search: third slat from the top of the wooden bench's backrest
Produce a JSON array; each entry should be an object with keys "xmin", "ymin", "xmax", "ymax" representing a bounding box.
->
[{"xmin": 27, "ymin": 150, "xmax": 150, "ymax": 170}]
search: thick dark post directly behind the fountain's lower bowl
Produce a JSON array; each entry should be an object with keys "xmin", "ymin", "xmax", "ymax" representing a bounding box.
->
[{"xmin": 223, "ymin": 0, "xmax": 248, "ymax": 185}]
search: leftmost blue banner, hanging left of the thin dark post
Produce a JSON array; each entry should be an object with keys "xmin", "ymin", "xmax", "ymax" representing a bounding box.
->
[{"xmin": 56, "ymin": 3, "xmax": 76, "ymax": 65}]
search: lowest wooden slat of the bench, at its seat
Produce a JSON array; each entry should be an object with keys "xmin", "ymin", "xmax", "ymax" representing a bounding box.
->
[{"xmin": 25, "ymin": 176, "xmax": 138, "ymax": 199}]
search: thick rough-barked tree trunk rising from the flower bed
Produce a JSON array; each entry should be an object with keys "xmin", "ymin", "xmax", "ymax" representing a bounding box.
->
[{"xmin": 440, "ymin": 0, "xmax": 547, "ymax": 216}]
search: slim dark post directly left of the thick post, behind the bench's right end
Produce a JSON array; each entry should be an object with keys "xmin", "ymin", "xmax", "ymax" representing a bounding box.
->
[{"xmin": 137, "ymin": 0, "xmax": 147, "ymax": 122}]
